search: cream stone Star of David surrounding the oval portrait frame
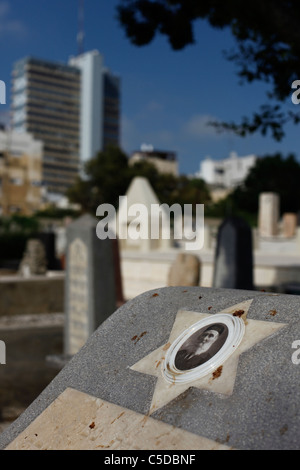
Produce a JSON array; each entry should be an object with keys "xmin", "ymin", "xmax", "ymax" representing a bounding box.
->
[{"xmin": 130, "ymin": 299, "xmax": 285, "ymax": 415}]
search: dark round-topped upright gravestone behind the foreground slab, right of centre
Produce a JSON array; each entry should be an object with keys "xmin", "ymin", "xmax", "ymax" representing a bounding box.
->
[{"xmin": 213, "ymin": 216, "xmax": 253, "ymax": 290}]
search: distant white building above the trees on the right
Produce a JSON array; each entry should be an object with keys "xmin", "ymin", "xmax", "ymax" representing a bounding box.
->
[{"xmin": 196, "ymin": 152, "xmax": 257, "ymax": 189}]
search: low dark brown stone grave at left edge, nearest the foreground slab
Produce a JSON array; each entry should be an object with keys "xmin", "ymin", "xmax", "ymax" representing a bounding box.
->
[{"xmin": 0, "ymin": 314, "xmax": 64, "ymax": 412}]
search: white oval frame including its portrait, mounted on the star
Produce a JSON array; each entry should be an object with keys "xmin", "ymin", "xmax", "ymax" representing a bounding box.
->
[{"xmin": 162, "ymin": 313, "xmax": 245, "ymax": 384}]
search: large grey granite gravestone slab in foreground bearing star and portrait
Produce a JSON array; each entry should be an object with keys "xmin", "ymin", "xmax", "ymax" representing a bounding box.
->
[{"xmin": 0, "ymin": 287, "xmax": 300, "ymax": 450}]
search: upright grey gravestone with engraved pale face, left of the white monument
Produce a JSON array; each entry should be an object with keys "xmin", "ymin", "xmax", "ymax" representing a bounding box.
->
[{"xmin": 64, "ymin": 215, "xmax": 117, "ymax": 356}]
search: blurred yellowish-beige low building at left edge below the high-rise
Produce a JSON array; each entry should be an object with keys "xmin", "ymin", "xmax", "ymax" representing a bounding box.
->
[{"xmin": 0, "ymin": 131, "xmax": 43, "ymax": 215}]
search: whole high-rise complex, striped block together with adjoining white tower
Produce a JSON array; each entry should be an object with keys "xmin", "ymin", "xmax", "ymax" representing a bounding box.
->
[{"xmin": 12, "ymin": 51, "xmax": 120, "ymax": 194}]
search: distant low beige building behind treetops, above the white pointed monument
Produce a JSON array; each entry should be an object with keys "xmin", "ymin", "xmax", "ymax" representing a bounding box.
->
[{"xmin": 129, "ymin": 144, "xmax": 178, "ymax": 176}]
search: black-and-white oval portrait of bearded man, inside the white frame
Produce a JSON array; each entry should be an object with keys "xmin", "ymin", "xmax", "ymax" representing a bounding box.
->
[{"xmin": 174, "ymin": 323, "xmax": 228, "ymax": 371}]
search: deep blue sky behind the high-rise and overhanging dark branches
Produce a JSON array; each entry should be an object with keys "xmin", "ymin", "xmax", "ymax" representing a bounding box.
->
[{"xmin": 0, "ymin": 0, "xmax": 299, "ymax": 174}]
